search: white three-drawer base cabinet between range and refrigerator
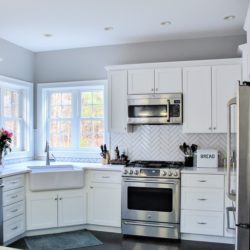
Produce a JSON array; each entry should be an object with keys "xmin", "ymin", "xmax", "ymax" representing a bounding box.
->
[{"xmin": 181, "ymin": 174, "xmax": 225, "ymax": 236}]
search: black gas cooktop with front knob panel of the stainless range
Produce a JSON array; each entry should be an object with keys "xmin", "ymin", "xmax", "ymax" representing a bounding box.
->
[{"xmin": 122, "ymin": 161, "xmax": 184, "ymax": 179}]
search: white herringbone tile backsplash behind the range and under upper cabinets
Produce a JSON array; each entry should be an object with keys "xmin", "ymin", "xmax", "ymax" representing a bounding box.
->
[{"xmin": 111, "ymin": 125, "xmax": 231, "ymax": 164}]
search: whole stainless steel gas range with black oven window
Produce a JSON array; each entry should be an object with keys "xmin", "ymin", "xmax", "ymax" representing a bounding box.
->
[{"xmin": 122, "ymin": 161, "xmax": 183, "ymax": 239}]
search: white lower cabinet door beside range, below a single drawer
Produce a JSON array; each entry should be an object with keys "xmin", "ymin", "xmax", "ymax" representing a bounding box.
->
[{"xmin": 88, "ymin": 183, "xmax": 121, "ymax": 227}]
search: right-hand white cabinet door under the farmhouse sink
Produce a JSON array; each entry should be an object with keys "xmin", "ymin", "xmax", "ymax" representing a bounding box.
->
[{"xmin": 58, "ymin": 190, "xmax": 87, "ymax": 227}]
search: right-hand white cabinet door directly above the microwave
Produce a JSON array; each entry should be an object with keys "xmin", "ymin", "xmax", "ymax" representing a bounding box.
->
[{"xmin": 155, "ymin": 68, "xmax": 182, "ymax": 94}]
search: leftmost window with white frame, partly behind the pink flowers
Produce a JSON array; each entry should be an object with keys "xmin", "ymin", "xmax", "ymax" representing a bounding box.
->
[{"xmin": 0, "ymin": 76, "xmax": 33, "ymax": 158}]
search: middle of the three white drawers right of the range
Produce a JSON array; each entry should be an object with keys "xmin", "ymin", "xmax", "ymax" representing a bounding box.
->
[{"xmin": 181, "ymin": 187, "xmax": 224, "ymax": 212}]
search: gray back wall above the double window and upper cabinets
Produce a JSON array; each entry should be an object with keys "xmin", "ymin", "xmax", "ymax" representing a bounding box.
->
[{"xmin": 35, "ymin": 35, "xmax": 246, "ymax": 82}]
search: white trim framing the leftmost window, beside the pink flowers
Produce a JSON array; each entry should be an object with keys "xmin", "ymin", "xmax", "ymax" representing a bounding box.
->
[{"xmin": 0, "ymin": 75, "xmax": 34, "ymax": 160}]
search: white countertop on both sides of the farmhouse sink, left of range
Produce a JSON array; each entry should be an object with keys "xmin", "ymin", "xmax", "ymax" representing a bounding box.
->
[{"xmin": 0, "ymin": 161, "xmax": 123, "ymax": 178}]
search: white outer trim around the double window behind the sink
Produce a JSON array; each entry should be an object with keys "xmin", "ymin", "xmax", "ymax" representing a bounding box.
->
[{"xmin": 35, "ymin": 80, "xmax": 109, "ymax": 159}]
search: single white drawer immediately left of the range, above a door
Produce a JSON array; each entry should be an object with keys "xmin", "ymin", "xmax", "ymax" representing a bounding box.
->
[{"xmin": 91, "ymin": 171, "xmax": 121, "ymax": 183}]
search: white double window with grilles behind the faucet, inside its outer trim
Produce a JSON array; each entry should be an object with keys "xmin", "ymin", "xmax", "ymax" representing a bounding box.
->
[{"xmin": 38, "ymin": 83, "xmax": 105, "ymax": 153}]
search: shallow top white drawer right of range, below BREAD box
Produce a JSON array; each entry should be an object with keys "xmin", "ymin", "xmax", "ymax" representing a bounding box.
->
[{"xmin": 181, "ymin": 174, "xmax": 224, "ymax": 188}]
